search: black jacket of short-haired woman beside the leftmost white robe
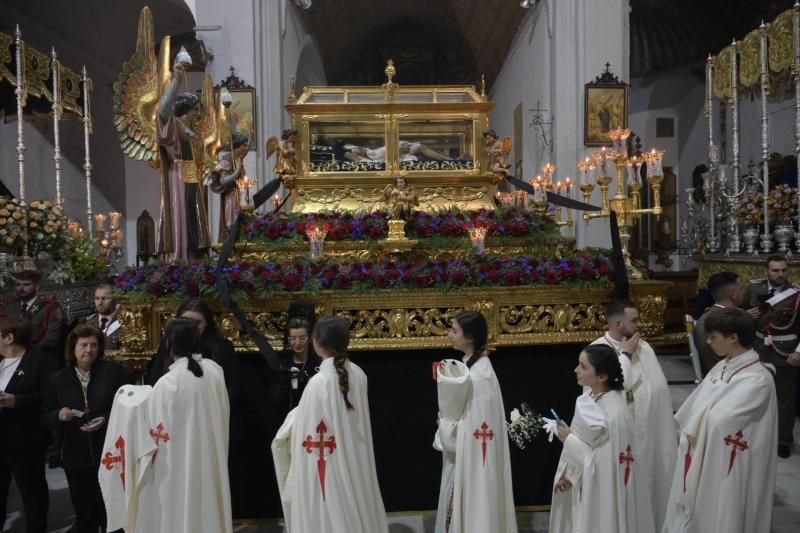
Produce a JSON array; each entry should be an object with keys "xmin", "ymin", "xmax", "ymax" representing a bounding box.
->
[{"xmin": 42, "ymin": 359, "xmax": 127, "ymax": 468}]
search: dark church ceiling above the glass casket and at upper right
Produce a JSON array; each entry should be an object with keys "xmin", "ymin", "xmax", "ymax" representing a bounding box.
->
[{"xmin": 302, "ymin": 0, "xmax": 793, "ymax": 85}]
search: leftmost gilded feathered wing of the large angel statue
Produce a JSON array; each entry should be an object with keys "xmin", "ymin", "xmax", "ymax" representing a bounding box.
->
[{"xmin": 114, "ymin": 7, "xmax": 163, "ymax": 161}]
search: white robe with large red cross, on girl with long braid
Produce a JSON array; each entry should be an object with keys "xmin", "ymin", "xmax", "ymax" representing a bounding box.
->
[{"xmin": 272, "ymin": 359, "xmax": 389, "ymax": 533}]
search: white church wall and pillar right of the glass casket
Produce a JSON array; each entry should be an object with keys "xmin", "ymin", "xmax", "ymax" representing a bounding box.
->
[{"xmin": 490, "ymin": 0, "xmax": 629, "ymax": 247}]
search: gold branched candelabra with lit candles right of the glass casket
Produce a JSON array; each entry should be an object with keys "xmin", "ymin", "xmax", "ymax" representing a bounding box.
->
[{"xmin": 578, "ymin": 128, "xmax": 664, "ymax": 279}]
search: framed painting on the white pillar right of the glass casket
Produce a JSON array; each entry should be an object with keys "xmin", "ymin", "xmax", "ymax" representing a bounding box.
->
[{"xmin": 583, "ymin": 63, "xmax": 628, "ymax": 146}]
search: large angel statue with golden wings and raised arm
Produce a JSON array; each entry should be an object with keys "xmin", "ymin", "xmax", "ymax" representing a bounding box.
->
[{"xmin": 114, "ymin": 7, "xmax": 230, "ymax": 261}]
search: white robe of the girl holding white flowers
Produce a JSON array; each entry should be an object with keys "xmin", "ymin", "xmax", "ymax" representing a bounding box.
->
[{"xmin": 549, "ymin": 391, "xmax": 656, "ymax": 533}]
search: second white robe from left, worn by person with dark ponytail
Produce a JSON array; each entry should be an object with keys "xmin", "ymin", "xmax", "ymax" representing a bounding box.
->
[{"xmin": 134, "ymin": 355, "xmax": 233, "ymax": 533}]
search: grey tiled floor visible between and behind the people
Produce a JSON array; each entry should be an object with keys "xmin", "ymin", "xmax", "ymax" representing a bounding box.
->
[{"xmin": 3, "ymin": 356, "xmax": 800, "ymax": 533}]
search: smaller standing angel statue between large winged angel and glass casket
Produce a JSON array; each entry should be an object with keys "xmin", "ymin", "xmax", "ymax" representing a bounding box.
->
[{"xmin": 209, "ymin": 131, "xmax": 250, "ymax": 237}]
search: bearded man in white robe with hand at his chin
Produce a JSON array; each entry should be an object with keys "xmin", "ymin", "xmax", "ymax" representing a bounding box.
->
[{"xmin": 592, "ymin": 300, "xmax": 678, "ymax": 531}]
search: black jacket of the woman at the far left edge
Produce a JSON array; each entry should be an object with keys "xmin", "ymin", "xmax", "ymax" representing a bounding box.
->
[{"xmin": 0, "ymin": 349, "xmax": 56, "ymax": 460}]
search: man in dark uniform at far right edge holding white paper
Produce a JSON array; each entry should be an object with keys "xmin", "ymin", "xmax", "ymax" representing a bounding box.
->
[{"xmin": 743, "ymin": 255, "xmax": 800, "ymax": 458}]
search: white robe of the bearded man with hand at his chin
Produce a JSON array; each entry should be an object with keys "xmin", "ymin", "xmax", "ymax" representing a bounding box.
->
[{"xmin": 592, "ymin": 333, "xmax": 678, "ymax": 529}]
